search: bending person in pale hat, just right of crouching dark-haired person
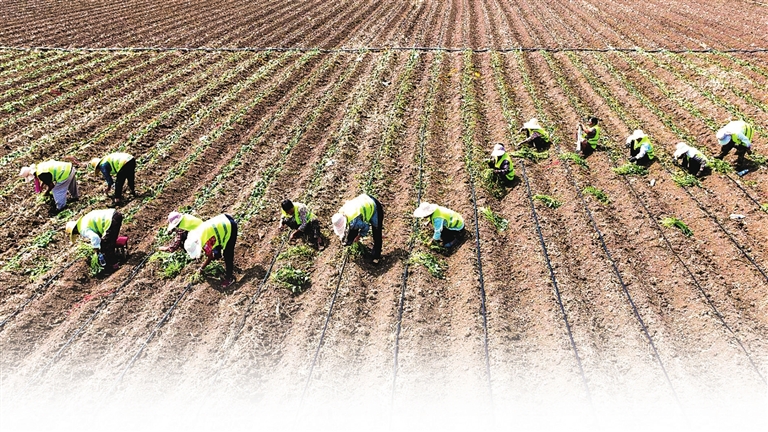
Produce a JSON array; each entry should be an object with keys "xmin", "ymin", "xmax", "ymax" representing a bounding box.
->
[{"xmin": 331, "ymin": 194, "xmax": 384, "ymax": 264}]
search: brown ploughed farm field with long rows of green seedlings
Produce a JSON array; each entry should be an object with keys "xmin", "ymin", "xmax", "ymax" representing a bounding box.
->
[{"xmin": 0, "ymin": 0, "xmax": 768, "ymax": 429}]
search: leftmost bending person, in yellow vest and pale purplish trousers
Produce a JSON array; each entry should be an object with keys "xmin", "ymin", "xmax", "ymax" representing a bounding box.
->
[{"xmin": 19, "ymin": 159, "xmax": 80, "ymax": 211}]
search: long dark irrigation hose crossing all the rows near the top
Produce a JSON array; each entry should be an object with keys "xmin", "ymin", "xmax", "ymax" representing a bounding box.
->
[{"xmin": 0, "ymin": 46, "xmax": 768, "ymax": 54}]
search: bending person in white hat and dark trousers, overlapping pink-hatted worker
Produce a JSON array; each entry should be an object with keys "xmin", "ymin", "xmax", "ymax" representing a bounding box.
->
[{"xmin": 184, "ymin": 214, "xmax": 237, "ymax": 288}]
